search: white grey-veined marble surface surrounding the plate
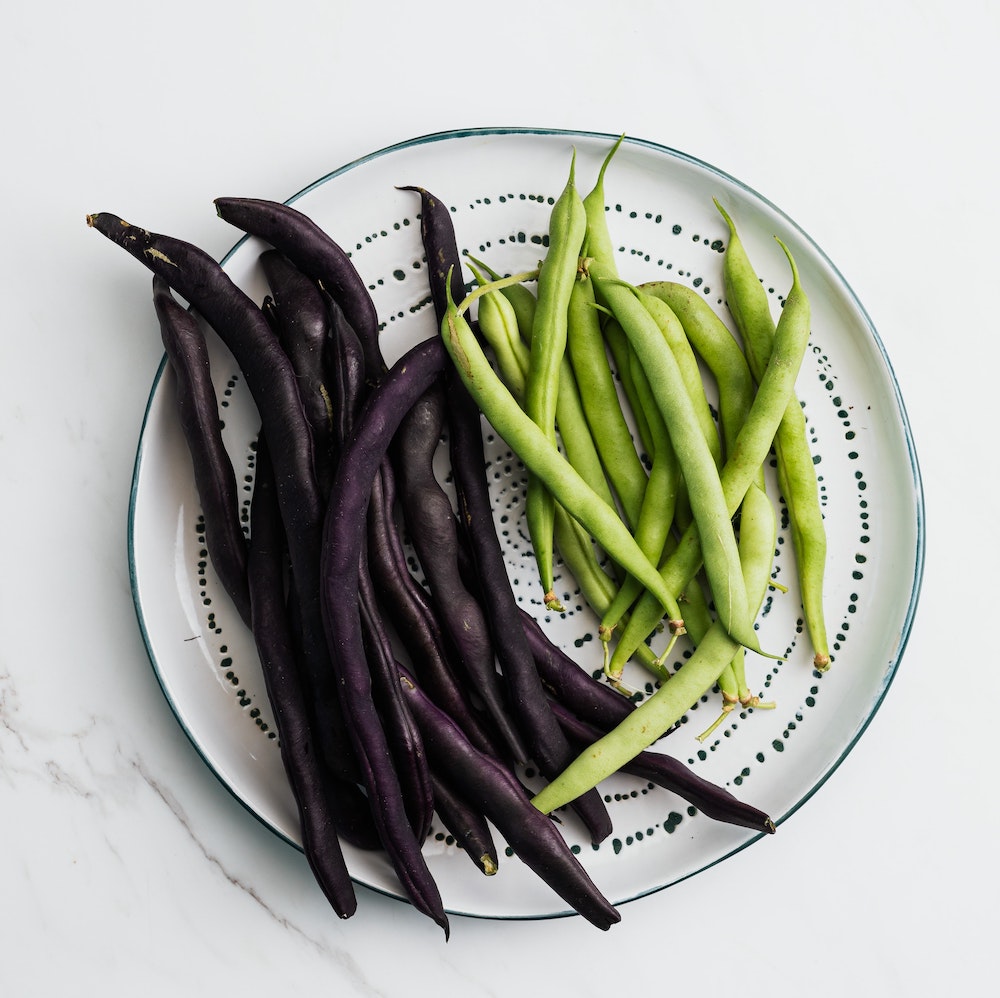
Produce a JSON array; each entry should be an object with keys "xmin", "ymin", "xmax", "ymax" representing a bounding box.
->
[{"xmin": 0, "ymin": 0, "xmax": 1000, "ymax": 998}]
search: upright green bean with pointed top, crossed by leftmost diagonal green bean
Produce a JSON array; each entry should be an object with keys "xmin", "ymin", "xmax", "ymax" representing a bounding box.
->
[{"xmin": 524, "ymin": 152, "xmax": 587, "ymax": 610}]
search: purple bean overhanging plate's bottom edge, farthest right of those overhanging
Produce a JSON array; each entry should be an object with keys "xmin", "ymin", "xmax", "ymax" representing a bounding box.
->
[{"xmin": 400, "ymin": 670, "xmax": 620, "ymax": 929}]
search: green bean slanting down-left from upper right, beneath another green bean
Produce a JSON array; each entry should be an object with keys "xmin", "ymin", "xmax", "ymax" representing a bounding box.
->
[{"xmin": 611, "ymin": 240, "xmax": 811, "ymax": 675}]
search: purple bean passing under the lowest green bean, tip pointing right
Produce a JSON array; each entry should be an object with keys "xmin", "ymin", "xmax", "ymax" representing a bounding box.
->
[{"xmin": 553, "ymin": 703, "xmax": 775, "ymax": 834}]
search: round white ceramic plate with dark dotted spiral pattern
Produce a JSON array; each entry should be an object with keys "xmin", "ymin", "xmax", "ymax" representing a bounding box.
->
[{"xmin": 129, "ymin": 129, "xmax": 923, "ymax": 918}]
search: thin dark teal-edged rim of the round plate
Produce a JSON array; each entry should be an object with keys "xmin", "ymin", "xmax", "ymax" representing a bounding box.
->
[{"xmin": 127, "ymin": 125, "xmax": 926, "ymax": 921}]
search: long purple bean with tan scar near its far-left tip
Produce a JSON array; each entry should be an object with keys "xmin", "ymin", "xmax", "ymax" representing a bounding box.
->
[{"xmin": 87, "ymin": 212, "xmax": 355, "ymax": 779}]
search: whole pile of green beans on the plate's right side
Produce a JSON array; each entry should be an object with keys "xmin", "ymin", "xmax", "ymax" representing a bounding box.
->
[{"xmin": 441, "ymin": 140, "xmax": 829, "ymax": 812}]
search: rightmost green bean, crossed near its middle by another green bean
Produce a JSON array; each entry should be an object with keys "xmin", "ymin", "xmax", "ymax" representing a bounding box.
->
[{"xmin": 715, "ymin": 201, "xmax": 830, "ymax": 670}]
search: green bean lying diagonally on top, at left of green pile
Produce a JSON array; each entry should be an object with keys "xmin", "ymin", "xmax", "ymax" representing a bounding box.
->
[{"xmin": 441, "ymin": 278, "xmax": 680, "ymax": 628}]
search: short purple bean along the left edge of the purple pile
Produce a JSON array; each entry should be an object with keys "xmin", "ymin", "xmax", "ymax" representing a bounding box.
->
[{"xmin": 153, "ymin": 276, "xmax": 250, "ymax": 626}]
